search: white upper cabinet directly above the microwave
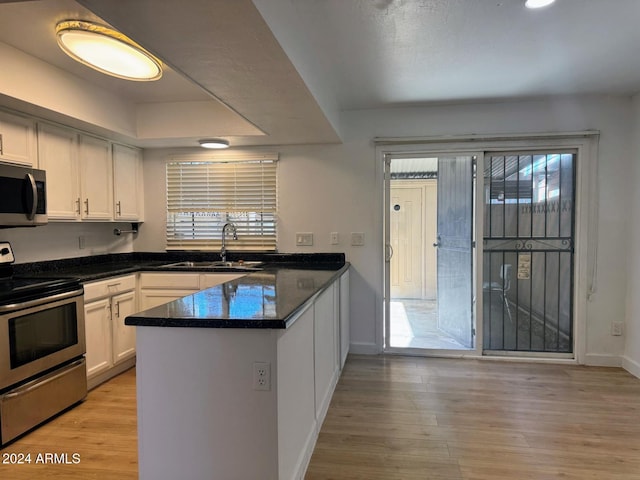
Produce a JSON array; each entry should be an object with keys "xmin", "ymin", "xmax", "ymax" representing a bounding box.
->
[{"xmin": 0, "ymin": 111, "xmax": 38, "ymax": 167}]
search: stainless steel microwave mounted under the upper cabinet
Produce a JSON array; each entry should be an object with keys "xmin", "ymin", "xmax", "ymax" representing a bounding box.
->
[{"xmin": 0, "ymin": 164, "xmax": 48, "ymax": 228}]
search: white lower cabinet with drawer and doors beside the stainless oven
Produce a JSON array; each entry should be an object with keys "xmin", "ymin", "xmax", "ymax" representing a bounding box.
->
[{"xmin": 84, "ymin": 275, "xmax": 137, "ymax": 387}]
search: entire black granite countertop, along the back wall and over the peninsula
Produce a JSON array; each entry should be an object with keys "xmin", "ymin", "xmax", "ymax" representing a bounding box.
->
[{"xmin": 13, "ymin": 252, "xmax": 349, "ymax": 329}]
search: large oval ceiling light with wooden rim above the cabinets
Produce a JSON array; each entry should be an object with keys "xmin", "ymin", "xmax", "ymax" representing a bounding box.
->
[{"xmin": 56, "ymin": 20, "xmax": 162, "ymax": 81}]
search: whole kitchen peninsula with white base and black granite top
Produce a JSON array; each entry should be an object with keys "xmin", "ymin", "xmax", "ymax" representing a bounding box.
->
[{"xmin": 125, "ymin": 263, "xmax": 349, "ymax": 480}]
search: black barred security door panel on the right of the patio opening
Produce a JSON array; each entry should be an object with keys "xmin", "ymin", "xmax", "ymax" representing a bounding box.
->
[{"xmin": 483, "ymin": 152, "xmax": 576, "ymax": 353}]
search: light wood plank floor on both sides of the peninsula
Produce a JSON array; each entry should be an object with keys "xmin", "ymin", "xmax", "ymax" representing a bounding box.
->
[{"xmin": 0, "ymin": 356, "xmax": 640, "ymax": 480}]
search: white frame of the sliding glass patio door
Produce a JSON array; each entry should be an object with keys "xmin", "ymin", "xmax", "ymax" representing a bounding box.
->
[{"xmin": 374, "ymin": 130, "xmax": 599, "ymax": 364}]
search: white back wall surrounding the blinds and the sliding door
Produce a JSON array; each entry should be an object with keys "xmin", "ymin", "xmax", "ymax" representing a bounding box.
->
[{"xmin": 134, "ymin": 97, "xmax": 640, "ymax": 365}]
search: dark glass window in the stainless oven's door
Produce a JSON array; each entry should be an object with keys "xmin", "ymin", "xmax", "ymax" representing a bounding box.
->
[{"xmin": 9, "ymin": 302, "xmax": 78, "ymax": 368}]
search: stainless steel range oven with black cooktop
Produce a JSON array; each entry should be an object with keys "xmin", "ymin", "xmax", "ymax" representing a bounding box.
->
[{"xmin": 0, "ymin": 243, "xmax": 87, "ymax": 445}]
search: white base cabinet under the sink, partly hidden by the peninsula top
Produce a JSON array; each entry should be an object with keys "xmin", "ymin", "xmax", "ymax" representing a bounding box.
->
[{"xmin": 140, "ymin": 272, "xmax": 246, "ymax": 310}]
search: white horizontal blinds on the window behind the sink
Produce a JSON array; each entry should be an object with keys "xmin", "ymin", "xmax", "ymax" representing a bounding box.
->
[{"xmin": 167, "ymin": 154, "xmax": 278, "ymax": 250}]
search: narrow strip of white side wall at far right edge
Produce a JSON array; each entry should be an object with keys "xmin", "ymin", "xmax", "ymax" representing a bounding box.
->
[{"xmin": 623, "ymin": 95, "xmax": 640, "ymax": 377}]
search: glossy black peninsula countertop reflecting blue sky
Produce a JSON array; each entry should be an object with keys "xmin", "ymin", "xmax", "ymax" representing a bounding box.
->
[{"xmin": 125, "ymin": 264, "xmax": 349, "ymax": 328}]
